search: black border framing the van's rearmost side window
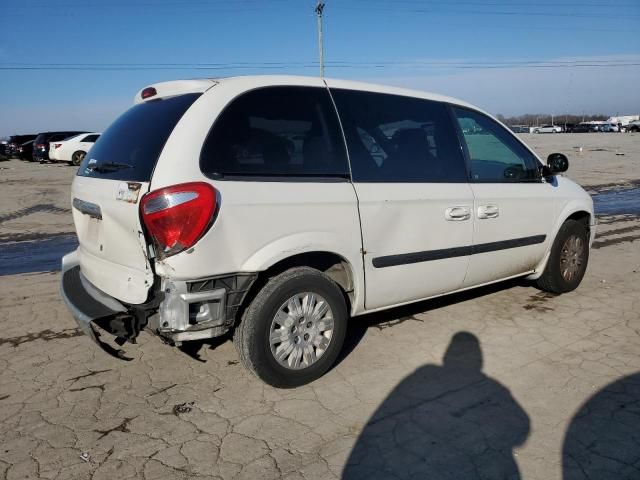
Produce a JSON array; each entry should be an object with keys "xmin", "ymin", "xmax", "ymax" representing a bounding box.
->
[{"xmin": 198, "ymin": 85, "xmax": 352, "ymax": 183}]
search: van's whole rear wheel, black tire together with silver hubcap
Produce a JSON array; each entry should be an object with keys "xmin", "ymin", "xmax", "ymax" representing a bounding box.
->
[{"xmin": 233, "ymin": 267, "xmax": 348, "ymax": 388}]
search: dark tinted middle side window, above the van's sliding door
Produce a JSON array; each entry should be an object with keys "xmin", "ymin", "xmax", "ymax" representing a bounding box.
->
[{"xmin": 331, "ymin": 89, "xmax": 467, "ymax": 183}]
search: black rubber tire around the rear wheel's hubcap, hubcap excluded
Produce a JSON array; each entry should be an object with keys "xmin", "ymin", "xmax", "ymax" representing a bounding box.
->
[{"xmin": 233, "ymin": 267, "xmax": 348, "ymax": 388}]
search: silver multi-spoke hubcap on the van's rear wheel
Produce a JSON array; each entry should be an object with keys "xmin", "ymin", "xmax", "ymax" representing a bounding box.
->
[{"xmin": 269, "ymin": 292, "xmax": 333, "ymax": 370}]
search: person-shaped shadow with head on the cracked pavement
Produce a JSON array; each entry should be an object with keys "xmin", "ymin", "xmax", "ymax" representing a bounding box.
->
[{"xmin": 343, "ymin": 332, "xmax": 530, "ymax": 480}]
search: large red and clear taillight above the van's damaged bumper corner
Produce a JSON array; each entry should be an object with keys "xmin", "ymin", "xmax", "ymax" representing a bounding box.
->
[{"xmin": 140, "ymin": 182, "xmax": 217, "ymax": 257}]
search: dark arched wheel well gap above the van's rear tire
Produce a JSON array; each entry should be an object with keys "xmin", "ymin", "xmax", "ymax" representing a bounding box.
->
[{"xmin": 235, "ymin": 252, "xmax": 354, "ymax": 323}]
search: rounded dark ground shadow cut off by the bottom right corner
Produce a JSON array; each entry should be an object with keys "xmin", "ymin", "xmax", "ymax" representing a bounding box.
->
[{"xmin": 562, "ymin": 373, "xmax": 640, "ymax": 480}]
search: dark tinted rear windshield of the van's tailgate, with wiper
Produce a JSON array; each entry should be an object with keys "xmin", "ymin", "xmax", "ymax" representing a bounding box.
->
[{"xmin": 78, "ymin": 93, "xmax": 201, "ymax": 182}]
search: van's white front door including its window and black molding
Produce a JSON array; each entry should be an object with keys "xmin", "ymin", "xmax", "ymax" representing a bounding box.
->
[{"xmin": 453, "ymin": 107, "xmax": 556, "ymax": 287}]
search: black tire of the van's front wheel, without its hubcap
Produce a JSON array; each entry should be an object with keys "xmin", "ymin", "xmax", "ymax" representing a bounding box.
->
[{"xmin": 537, "ymin": 220, "xmax": 589, "ymax": 293}]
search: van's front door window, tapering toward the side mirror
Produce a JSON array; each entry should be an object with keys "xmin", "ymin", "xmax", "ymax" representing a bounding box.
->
[{"xmin": 453, "ymin": 107, "xmax": 540, "ymax": 183}]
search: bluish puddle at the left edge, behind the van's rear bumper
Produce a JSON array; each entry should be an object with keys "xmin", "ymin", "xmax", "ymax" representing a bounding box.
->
[{"xmin": 0, "ymin": 234, "xmax": 78, "ymax": 275}]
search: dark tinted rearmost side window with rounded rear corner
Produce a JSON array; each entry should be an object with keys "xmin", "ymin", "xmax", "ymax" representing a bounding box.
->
[{"xmin": 200, "ymin": 87, "xmax": 349, "ymax": 178}]
